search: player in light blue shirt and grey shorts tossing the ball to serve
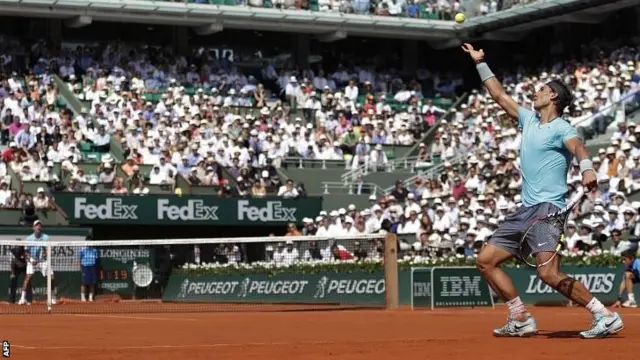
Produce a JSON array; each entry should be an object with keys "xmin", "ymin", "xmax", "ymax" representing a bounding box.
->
[{"xmin": 462, "ymin": 44, "xmax": 624, "ymax": 339}]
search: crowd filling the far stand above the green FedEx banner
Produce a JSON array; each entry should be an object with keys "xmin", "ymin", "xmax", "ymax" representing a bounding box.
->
[{"xmin": 0, "ymin": 41, "xmax": 461, "ymax": 206}]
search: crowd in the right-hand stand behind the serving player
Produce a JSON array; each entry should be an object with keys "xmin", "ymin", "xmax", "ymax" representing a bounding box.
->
[{"xmin": 236, "ymin": 43, "xmax": 640, "ymax": 268}]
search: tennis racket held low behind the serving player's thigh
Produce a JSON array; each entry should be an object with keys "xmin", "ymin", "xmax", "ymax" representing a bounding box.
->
[{"xmin": 520, "ymin": 189, "xmax": 584, "ymax": 268}]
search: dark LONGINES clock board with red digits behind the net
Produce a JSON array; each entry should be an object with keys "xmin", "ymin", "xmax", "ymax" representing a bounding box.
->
[{"xmin": 97, "ymin": 247, "xmax": 154, "ymax": 297}]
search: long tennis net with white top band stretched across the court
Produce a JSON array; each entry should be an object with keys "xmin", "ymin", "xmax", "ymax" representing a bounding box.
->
[{"xmin": 0, "ymin": 235, "xmax": 397, "ymax": 314}]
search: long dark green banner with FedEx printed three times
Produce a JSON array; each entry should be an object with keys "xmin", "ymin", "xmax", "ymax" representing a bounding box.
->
[{"xmin": 56, "ymin": 193, "xmax": 322, "ymax": 226}]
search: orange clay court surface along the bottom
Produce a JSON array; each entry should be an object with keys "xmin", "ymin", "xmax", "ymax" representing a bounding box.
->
[{"xmin": 0, "ymin": 304, "xmax": 640, "ymax": 360}]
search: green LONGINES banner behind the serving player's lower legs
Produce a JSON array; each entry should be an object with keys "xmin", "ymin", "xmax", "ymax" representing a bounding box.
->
[{"xmin": 505, "ymin": 266, "xmax": 639, "ymax": 304}]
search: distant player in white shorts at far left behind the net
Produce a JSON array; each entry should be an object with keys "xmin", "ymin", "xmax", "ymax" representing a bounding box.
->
[{"xmin": 18, "ymin": 220, "xmax": 57, "ymax": 305}]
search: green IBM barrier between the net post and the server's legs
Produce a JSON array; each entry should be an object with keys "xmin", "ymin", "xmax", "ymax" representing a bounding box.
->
[{"xmin": 411, "ymin": 267, "xmax": 494, "ymax": 309}]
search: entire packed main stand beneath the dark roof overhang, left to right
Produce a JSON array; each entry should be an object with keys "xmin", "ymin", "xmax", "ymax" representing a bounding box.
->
[{"xmin": 2, "ymin": 19, "xmax": 640, "ymax": 262}]
